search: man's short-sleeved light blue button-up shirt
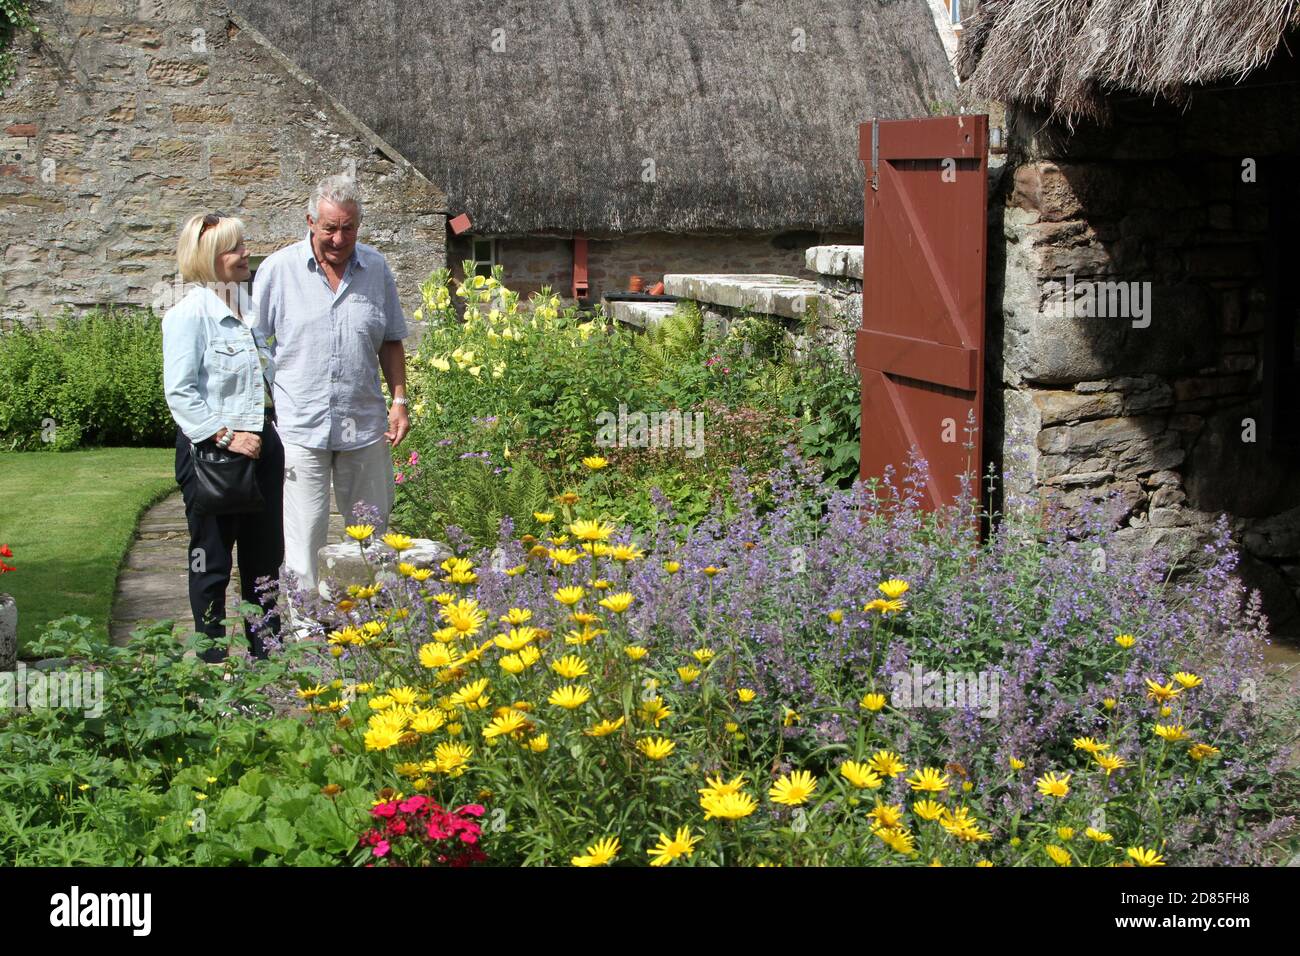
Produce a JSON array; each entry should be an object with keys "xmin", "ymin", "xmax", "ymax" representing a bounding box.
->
[{"xmin": 252, "ymin": 234, "xmax": 407, "ymax": 451}]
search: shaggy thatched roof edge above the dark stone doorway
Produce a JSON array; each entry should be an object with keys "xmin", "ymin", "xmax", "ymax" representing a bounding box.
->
[{"xmin": 957, "ymin": 0, "xmax": 1300, "ymax": 121}]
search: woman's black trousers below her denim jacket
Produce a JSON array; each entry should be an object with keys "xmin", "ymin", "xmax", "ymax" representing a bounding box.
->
[{"xmin": 176, "ymin": 419, "xmax": 285, "ymax": 663}]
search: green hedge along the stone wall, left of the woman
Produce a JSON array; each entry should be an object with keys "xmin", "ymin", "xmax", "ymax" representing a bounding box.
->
[{"xmin": 0, "ymin": 310, "xmax": 176, "ymax": 450}]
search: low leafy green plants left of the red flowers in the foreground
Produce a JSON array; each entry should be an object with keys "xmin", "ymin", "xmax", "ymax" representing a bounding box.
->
[{"xmin": 0, "ymin": 618, "xmax": 371, "ymax": 866}]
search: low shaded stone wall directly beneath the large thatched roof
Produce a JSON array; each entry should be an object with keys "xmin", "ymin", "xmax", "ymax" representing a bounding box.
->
[{"xmin": 449, "ymin": 233, "xmax": 862, "ymax": 302}]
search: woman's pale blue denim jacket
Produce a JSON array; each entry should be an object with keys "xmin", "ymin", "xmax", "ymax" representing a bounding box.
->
[{"xmin": 163, "ymin": 285, "xmax": 276, "ymax": 442}]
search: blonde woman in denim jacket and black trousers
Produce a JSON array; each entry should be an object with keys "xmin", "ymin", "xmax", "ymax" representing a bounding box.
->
[{"xmin": 163, "ymin": 213, "xmax": 285, "ymax": 663}]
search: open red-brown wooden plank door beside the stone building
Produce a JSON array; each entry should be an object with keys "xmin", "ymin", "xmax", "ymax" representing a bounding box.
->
[{"xmin": 855, "ymin": 116, "xmax": 988, "ymax": 509}]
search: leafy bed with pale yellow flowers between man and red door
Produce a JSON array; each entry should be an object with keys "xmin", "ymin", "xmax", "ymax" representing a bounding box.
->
[{"xmin": 395, "ymin": 271, "xmax": 858, "ymax": 545}]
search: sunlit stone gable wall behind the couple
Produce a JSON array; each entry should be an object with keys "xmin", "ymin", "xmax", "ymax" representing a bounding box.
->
[{"xmin": 0, "ymin": 0, "xmax": 446, "ymax": 321}]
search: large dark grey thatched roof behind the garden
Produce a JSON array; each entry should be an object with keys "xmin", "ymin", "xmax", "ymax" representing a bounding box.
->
[{"xmin": 231, "ymin": 0, "xmax": 956, "ymax": 234}]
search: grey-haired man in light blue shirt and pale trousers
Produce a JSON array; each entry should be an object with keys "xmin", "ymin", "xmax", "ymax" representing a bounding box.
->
[{"xmin": 254, "ymin": 176, "xmax": 411, "ymax": 589}]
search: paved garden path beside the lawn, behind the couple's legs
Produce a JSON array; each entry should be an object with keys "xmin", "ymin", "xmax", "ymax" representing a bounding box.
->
[{"xmin": 109, "ymin": 490, "xmax": 343, "ymax": 644}]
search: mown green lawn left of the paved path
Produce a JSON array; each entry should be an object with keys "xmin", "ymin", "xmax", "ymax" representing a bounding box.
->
[{"xmin": 0, "ymin": 449, "xmax": 176, "ymax": 654}]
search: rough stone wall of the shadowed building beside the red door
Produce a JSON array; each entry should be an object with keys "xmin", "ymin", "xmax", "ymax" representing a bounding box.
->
[{"xmin": 989, "ymin": 86, "xmax": 1300, "ymax": 622}]
